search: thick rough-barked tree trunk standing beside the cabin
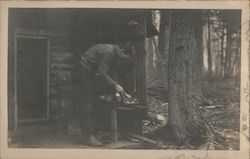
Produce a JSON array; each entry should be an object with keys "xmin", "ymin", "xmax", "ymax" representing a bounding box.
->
[{"xmin": 168, "ymin": 10, "xmax": 208, "ymax": 142}]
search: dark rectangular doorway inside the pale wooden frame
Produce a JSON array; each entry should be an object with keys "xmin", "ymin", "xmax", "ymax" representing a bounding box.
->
[{"xmin": 16, "ymin": 38, "xmax": 48, "ymax": 120}]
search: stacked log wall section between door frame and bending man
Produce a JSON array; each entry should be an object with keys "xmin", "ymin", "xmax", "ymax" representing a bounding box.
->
[{"xmin": 46, "ymin": 34, "xmax": 74, "ymax": 119}]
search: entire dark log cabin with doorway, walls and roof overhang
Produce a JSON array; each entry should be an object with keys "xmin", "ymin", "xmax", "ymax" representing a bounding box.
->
[{"xmin": 8, "ymin": 8, "xmax": 157, "ymax": 139}]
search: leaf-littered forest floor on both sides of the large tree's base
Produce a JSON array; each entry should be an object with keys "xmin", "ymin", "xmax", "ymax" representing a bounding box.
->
[{"xmin": 146, "ymin": 79, "xmax": 240, "ymax": 150}]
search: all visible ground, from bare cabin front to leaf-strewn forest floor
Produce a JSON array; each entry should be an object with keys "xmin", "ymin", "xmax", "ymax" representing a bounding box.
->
[{"xmin": 8, "ymin": 80, "xmax": 240, "ymax": 150}]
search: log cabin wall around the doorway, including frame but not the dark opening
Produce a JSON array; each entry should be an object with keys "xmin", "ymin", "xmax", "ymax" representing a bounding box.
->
[{"xmin": 8, "ymin": 27, "xmax": 77, "ymax": 129}]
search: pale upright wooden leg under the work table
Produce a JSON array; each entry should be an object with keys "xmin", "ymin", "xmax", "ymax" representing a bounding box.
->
[{"xmin": 111, "ymin": 108, "xmax": 118, "ymax": 142}]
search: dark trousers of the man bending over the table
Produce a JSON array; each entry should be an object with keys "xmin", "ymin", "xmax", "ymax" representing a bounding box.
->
[{"xmin": 72, "ymin": 63, "xmax": 97, "ymax": 135}]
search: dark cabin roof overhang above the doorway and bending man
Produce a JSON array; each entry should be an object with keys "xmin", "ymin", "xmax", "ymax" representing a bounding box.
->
[{"xmin": 10, "ymin": 8, "xmax": 158, "ymax": 42}]
